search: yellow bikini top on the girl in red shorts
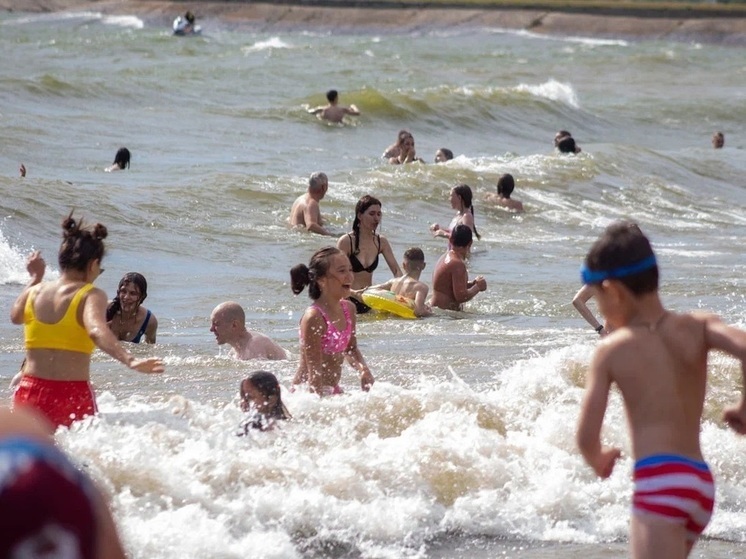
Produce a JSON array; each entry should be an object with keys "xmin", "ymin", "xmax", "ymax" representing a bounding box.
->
[{"xmin": 23, "ymin": 283, "xmax": 96, "ymax": 354}]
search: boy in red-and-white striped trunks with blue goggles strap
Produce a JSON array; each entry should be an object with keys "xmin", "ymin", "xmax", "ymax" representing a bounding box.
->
[{"xmin": 577, "ymin": 222, "xmax": 746, "ymax": 559}]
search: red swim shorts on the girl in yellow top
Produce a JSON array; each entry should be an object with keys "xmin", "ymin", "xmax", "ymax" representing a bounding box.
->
[{"xmin": 13, "ymin": 375, "xmax": 98, "ymax": 427}]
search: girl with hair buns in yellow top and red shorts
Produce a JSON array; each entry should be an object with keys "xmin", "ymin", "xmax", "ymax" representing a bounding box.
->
[{"xmin": 10, "ymin": 212, "xmax": 164, "ymax": 426}]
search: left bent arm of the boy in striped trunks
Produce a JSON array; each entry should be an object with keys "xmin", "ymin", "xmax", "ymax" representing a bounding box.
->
[{"xmin": 576, "ymin": 348, "xmax": 621, "ymax": 478}]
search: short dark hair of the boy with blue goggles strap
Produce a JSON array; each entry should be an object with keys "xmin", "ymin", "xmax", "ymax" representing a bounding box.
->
[{"xmin": 585, "ymin": 221, "xmax": 658, "ymax": 295}]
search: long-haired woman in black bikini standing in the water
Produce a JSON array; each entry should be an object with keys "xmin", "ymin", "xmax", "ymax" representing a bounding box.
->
[{"xmin": 337, "ymin": 194, "xmax": 402, "ymax": 314}]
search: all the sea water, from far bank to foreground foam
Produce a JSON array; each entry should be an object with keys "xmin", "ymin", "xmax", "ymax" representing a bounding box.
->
[{"xmin": 0, "ymin": 12, "xmax": 746, "ymax": 559}]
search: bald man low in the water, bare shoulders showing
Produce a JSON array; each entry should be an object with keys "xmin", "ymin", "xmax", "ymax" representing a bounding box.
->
[{"xmin": 210, "ymin": 301, "xmax": 288, "ymax": 361}]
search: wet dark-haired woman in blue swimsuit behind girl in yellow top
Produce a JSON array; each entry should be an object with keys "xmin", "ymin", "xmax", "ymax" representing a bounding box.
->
[{"xmin": 106, "ymin": 272, "xmax": 158, "ymax": 344}]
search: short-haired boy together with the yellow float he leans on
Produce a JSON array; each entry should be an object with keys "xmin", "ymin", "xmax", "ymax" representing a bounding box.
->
[{"xmin": 362, "ymin": 247, "xmax": 433, "ymax": 318}]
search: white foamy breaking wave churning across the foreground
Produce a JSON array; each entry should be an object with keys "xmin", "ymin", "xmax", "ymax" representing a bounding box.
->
[{"xmin": 57, "ymin": 346, "xmax": 746, "ymax": 559}]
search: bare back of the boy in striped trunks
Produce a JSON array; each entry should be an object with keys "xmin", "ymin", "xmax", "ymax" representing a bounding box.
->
[{"xmin": 598, "ymin": 312, "xmax": 709, "ymax": 459}]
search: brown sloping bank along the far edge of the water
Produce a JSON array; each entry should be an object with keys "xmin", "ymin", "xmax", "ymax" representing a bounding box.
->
[{"xmin": 0, "ymin": 0, "xmax": 746, "ymax": 45}]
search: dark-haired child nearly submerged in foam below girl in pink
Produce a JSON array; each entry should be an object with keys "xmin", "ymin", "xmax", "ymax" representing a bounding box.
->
[{"xmin": 239, "ymin": 371, "xmax": 292, "ymax": 435}]
